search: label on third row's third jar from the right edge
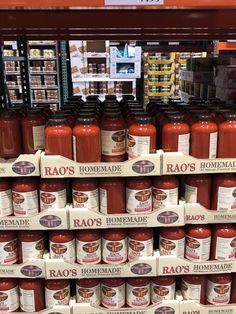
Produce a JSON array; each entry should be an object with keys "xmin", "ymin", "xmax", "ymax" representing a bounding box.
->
[{"xmin": 159, "ymin": 235, "xmax": 185, "ymax": 258}]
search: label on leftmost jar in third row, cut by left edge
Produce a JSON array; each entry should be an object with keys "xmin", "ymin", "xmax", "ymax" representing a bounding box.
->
[{"xmin": 0, "ymin": 239, "xmax": 18, "ymax": 264}]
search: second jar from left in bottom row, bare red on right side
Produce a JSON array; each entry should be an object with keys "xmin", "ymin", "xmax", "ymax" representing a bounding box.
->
[{"xmin": 19, "ymin": 278, "xmax": 45, "ymax": 312}]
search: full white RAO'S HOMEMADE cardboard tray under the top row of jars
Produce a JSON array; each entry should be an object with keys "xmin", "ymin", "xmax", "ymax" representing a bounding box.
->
[{"xmin": 40, "ymin": 153, "xmax": 161, "ymax": 178}]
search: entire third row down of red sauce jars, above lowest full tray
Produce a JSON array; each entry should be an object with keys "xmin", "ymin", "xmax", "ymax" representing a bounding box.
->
[{"xmin": 0, "ymin": 224, "xmax": 236, "ymax": 265}]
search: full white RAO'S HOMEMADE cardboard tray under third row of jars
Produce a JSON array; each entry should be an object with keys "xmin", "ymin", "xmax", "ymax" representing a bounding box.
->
[{"xmin": 45, "ymin": 255, "xmax": 157, "ymax": 279}]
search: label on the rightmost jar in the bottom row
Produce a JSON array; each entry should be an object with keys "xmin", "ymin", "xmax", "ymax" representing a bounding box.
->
[{"xmin": 206, "ymin": 280, "xmax": 231, "ymax": 304}]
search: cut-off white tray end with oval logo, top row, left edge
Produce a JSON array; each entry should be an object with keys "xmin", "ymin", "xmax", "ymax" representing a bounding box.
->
[{"xmin": 0, "ymin": 151, "xmax": 41, "ymax": 177}]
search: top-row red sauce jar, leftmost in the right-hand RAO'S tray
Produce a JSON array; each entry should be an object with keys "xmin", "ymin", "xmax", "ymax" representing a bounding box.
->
[{"xmin": 162, "ymin": 115, "xmax": 190, "ymax": 155}]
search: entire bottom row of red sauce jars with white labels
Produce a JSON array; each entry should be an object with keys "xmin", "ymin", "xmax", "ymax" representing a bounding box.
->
[{"xmin": 0, "ymin": 274, "xmax": 236, "ymax": 313}]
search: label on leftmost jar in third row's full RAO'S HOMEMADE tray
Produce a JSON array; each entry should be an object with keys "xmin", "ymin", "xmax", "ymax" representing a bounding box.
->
[{"xmin": 49, "ymin": 239, "xmax": 75, "ymax": 263}]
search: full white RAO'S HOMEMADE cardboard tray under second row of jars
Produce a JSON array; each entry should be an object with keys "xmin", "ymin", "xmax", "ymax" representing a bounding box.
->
[{"xmin": 69, "ymin": 205, "xmax": 185, "ymax": 229}]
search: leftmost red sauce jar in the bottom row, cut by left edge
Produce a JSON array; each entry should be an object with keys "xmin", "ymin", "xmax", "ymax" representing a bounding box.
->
[{"xmin": 0, "ymin": 278, "xmax": 20, "ymax": 313}]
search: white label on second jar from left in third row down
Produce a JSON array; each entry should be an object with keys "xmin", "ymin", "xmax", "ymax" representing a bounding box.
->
[{"xmin": 21, "ymin": 238, "xmax": 44, "ymax": 263}]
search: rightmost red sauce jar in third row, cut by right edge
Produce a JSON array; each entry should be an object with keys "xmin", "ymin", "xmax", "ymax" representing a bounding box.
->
[{"xmin": 211, "ymin": 224, "xmax": 236, "ymax": 261}]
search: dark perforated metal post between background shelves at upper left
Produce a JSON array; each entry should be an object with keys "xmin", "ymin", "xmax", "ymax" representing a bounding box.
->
[{"xmin": 17, "ymin": 35, "xmax": 32, "ymax": 108}]
